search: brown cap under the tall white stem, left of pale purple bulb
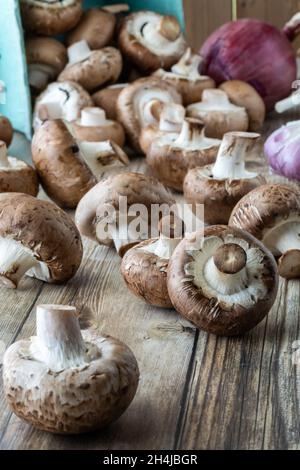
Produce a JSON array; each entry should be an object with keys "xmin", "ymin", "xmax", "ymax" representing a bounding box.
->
[{"xmin": 183, "ymin": 165, "xmax": 266, "ymax": 225}]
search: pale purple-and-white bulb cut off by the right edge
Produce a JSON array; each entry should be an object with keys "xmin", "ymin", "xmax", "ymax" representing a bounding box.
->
[{"xmin": 265, "ymin": 121, "xmax": 300, "ymax": 181}]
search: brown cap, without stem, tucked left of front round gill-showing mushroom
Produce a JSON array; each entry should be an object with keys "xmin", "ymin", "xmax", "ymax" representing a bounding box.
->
[{"xmin": 121, "ymin": 239, "xmax": 172, "ymax": 308}]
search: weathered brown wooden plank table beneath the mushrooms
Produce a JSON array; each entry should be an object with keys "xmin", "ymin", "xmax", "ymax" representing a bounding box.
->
[{"xmin": 0, "ymin": 114, "xmax": 300, "ymax": 450}]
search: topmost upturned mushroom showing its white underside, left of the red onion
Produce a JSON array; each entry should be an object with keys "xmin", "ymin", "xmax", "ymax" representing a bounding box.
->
[{"xmin": 119, "ymin": 11, "xmax": 187, "ymax": 72}]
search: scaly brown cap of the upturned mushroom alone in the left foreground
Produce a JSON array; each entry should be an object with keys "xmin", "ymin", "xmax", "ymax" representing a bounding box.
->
[{"xmin": 3, "ymin": 329, "xmax": 139, "ymax": 434}]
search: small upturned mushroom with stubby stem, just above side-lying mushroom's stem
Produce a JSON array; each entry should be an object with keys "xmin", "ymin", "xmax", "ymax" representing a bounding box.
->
[{"xmin": 71, "ymin": 107, "xmax": 125, "ymax": 147}]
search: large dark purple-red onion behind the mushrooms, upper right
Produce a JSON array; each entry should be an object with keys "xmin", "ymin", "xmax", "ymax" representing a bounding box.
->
[{"xmin": 200, "ymin": 19, "xmax": 297, "ymax": 111}]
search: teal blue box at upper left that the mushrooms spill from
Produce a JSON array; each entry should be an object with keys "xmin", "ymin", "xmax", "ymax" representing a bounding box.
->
[{"xmin": 0, "ymin": 0, "xmax": 184, "ymax": 139}]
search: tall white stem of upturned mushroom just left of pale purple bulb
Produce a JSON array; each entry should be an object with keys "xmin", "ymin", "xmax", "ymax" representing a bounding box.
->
[{"xmin": 212, "ymin": 132, "xmax": 260, "ymax": 180}]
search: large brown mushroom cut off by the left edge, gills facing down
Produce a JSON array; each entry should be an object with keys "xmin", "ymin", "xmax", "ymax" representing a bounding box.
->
[{"xmin": 0, "ymin": 193, "xmax": 82, "ymax": 288}]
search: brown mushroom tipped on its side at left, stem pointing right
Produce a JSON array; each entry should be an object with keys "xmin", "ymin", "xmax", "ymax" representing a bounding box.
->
[{"xmin": 32, "ymin": 119, "xmax": 128, "ymax": 208}]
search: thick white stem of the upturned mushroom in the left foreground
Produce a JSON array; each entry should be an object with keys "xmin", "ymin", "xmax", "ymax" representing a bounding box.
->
[{"xmin": 31, "ymin": 305, "xmax": 87, "ymax": 371}]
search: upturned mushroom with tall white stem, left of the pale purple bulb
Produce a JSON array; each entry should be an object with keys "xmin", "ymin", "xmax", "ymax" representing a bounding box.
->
[{"xmin": 183, "ymin": 132, "xmax": 266, "ymax": 225}]
